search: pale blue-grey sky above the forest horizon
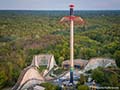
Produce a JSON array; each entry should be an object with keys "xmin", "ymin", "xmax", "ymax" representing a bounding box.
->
[{"xmin": 0, "ymin": 0, "xmax": 120, "ymax": 10}]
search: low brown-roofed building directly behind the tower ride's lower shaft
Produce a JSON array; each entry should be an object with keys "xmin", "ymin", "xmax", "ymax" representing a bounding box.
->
[{"xmin": 62, "ymin": 59, "xmax": 88, "ymax": 69}]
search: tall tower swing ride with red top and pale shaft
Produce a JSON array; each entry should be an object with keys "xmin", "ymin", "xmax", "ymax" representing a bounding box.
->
[{"xmin": 60, "ymin": 4, "xmax": 85, "ymax": 84}]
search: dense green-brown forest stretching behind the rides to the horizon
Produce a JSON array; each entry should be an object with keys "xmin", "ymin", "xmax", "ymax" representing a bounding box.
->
[{"xmin": 0, "ymin": 10, "xmax": 120, "ymax": 88}]
